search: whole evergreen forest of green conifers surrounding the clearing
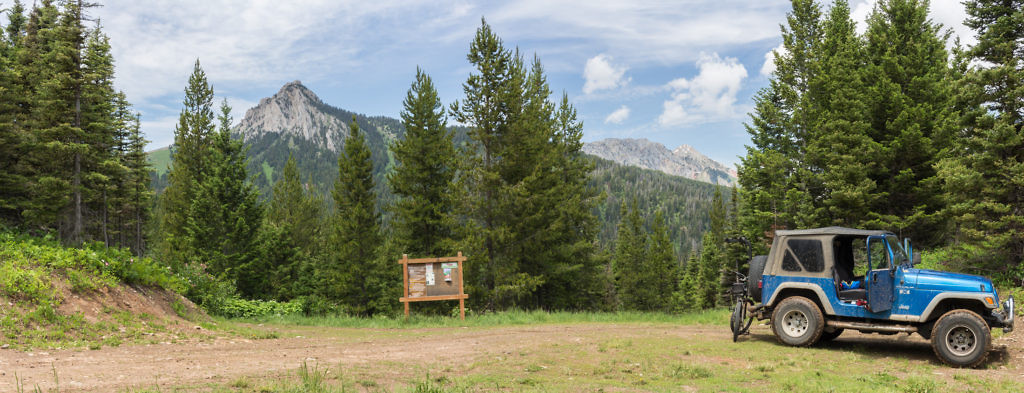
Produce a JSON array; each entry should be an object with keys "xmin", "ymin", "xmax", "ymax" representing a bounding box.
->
[{"xmin": 0, "ymin": 0, "xmax": 1024, "ymax": 316}]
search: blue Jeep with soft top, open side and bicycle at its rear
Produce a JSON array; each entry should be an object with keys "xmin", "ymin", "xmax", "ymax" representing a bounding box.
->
[{"xmin": 733, "ymin": 227, "xmax": 1014, "ymax": 367}]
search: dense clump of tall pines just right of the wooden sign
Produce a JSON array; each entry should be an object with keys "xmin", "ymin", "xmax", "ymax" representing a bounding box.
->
[{"xmin": 450, "ymin": 21, "xmax": 602, "ymax": 309}]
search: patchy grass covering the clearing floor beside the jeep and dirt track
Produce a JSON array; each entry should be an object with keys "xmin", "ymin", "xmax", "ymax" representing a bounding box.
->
[{"xmin": 132, "ymin": 310, "xmax": 1024, "ymax": 393}]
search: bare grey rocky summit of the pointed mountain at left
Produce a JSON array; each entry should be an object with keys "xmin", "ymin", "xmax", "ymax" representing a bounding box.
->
[{"xmin": 234, "ymin": 81, "xmax": 348, "ymax": 151}]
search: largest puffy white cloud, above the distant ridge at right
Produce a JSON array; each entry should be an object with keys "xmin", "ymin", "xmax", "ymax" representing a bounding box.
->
[{"xmin": 657, "ymin": 53, "xmax": 746, "ymax": 126}]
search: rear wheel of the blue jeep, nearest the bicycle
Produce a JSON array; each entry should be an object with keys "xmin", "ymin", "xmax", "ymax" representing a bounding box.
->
[{"xmin": 771, "ymin": 296, "xmax": 825, "ymax": 347}]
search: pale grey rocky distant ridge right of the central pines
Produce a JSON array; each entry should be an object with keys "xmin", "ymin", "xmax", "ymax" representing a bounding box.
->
[{"xmin": 583, "ymin": 138, "xmax": 736, "ymax": 186}]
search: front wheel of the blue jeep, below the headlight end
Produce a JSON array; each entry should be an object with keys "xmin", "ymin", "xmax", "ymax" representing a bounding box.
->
[{"xmin": 932, "ymin": 309, "xmax": 992, "ymax": 367}]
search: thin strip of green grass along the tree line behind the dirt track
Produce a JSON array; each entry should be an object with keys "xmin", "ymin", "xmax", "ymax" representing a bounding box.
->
[{"xmin": 233, "ymin": 309, "xmax": 729, "ymax": 329}]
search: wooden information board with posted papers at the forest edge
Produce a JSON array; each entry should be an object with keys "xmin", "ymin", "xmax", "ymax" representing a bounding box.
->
[{"xmin": 398, "ymin": 251, "xmax": 469, "ymax": 320}]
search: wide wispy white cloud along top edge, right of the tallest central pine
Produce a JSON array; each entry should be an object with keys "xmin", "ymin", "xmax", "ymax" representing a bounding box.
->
[{"xmin": 487, "ymin": 0, "xmax": 790, "ymax": 67}]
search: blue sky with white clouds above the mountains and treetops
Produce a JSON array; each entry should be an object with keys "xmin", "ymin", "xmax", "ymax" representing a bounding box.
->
[{"xmin": 91, "ymin": 0, "xmax": 972, "ymax": 166}]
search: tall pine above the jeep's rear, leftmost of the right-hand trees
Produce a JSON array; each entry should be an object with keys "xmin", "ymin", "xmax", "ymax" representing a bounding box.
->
[{"xmin": 738, "ymin": 0, "xmax": 822, "ymax": 242}]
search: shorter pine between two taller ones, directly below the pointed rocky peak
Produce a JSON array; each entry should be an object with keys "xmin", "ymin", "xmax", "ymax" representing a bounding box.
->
[{"xmin": 261, "ymin": 155, "xmax": 326, "ymax": 300}]
